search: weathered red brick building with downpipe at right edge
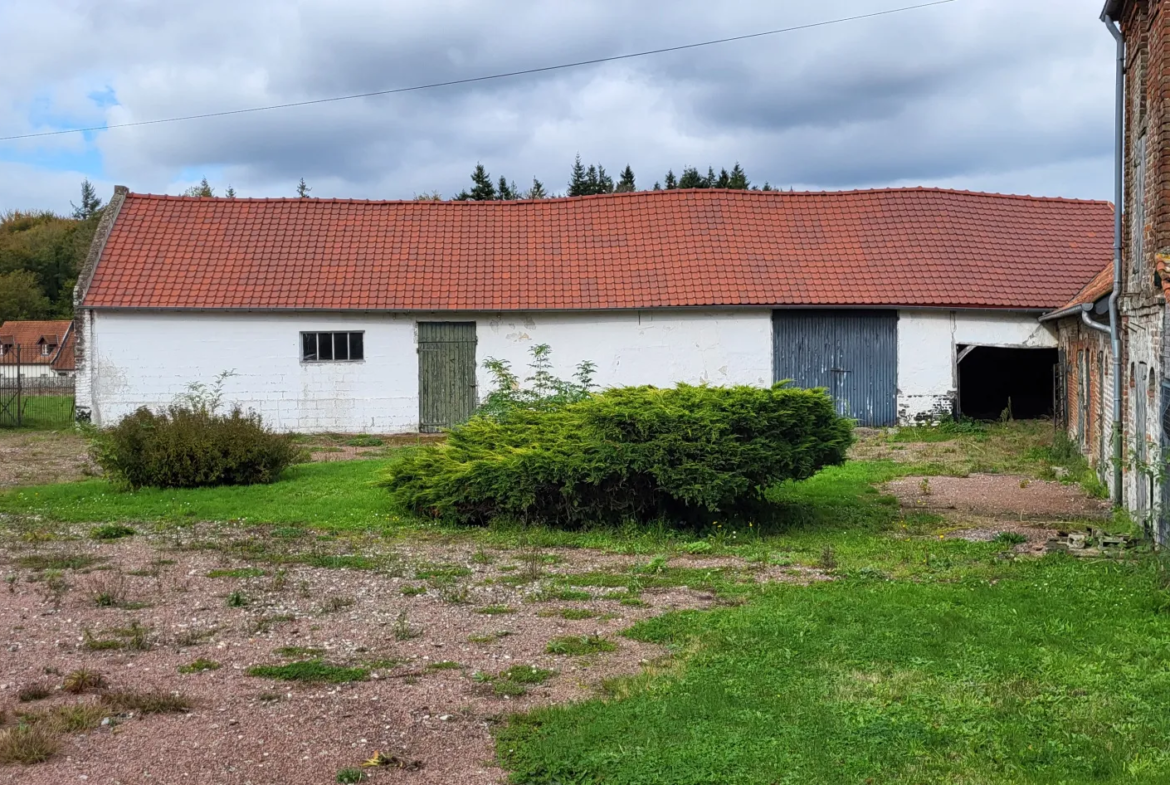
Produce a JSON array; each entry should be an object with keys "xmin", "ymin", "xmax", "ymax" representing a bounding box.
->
[{"xmin": 1046, "ymin": 0, "xmax": 1170, "ymax": 542}]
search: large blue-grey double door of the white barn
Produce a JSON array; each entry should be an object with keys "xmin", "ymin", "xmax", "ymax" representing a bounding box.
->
[{"xmin": 772, "ymin": 310, "xmax": 897, "ymax": 426}]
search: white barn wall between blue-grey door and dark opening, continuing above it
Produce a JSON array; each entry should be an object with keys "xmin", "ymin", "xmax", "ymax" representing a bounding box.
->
[{"xmin": 897, "ymin": 310, "xmax": 1057, "ymax": 425}]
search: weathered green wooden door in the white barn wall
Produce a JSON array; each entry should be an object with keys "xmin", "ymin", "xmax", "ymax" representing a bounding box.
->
[{"xmin": 419, "ymin": 322, "xmax": 477, "ymax": 433}]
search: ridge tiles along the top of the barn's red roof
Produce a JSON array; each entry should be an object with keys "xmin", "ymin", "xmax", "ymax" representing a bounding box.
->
[{"xmin": 128, "ymin": 185, "xmax": 1113, "ymax": 209}]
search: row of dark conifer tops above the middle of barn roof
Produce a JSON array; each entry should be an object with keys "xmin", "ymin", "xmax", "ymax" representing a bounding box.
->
[{"xmin": 449, "ymin": 156, "xmax": 773, "ymax": 201}]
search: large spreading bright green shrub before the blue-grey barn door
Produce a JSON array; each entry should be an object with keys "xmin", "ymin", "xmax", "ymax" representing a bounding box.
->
[{"xmin": 384, "ymin": 384, "xmax": 853, "ymax": 525}]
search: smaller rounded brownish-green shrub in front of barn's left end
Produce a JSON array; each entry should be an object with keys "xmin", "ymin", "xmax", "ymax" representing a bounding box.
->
[{"xmin": 94, "ymin": 404, "xmax": 301, "ymax": 488}]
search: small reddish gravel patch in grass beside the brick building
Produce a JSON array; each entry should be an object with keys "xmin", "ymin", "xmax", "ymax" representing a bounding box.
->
[{"xmin": 886, "ymin": 474, "xmax": 1109, "ymax": 521}]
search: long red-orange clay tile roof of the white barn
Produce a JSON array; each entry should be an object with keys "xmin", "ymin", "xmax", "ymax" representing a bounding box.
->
[{"xmin": 84, "ymin": 188, "xmax": 1113, "ymax": 311}]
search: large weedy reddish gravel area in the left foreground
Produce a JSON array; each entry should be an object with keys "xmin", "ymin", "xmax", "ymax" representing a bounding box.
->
[{"xmin": 0, "ymin": 530, "xmax": 824, "ymax": 785}]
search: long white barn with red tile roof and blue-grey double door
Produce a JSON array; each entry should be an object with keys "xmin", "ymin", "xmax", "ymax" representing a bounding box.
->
[{"xmin": 75, "ymin": 187, "xmax": 1113, "ymax": 433}]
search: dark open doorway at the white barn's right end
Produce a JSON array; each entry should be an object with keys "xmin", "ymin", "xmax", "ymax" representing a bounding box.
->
[{"xmin": 956, "ymin": 346, "xmax": 1057, "ymax": 420}]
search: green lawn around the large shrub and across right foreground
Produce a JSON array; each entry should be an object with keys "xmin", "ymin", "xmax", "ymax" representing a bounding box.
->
[{"xmin": 0, "ymin": 426, "xmax": 1170, "ymax": 785}]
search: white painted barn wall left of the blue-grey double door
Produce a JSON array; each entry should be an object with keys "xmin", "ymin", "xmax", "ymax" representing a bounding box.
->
[{"xmin": 77, "ymin": 310, "xmax": 772, "ymax": 433}]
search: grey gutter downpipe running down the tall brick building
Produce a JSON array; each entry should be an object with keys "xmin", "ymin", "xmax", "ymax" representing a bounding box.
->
[{"xmin": 1104, "ymin": 14, "xmax": 1126, "ymax": 507}]
